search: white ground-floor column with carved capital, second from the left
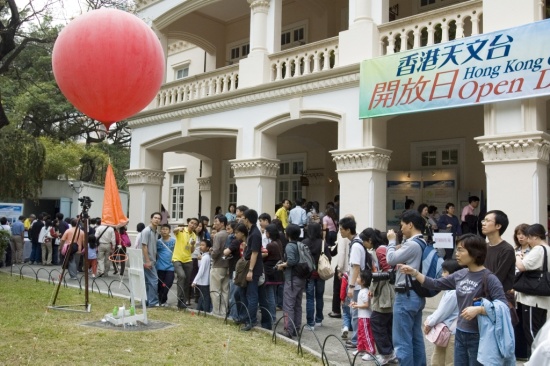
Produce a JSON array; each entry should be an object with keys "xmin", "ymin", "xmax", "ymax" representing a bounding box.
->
[{"xmin": 231, "ymin": 158, "xmax": 279, "ymax": 214}]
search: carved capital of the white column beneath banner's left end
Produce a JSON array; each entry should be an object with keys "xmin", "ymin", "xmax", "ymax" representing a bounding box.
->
[{"xmin": 330, "ymin": 146, "xmax": 391, "ymax": 172}]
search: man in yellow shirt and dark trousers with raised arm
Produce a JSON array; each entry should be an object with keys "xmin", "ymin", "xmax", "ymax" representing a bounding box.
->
[{"xmin": 172, "ymin": 218, "xmax": 199, "ymax": 309}]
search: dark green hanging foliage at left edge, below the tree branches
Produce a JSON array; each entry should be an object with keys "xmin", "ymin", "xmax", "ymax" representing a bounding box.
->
[{"xmin": 0, "ymin": 126, "xmax": 46, "ymax": 200}]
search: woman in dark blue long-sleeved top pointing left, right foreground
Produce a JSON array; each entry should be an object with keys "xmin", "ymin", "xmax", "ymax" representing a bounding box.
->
[{"xmin": 400, "ymin": 233, "xmax": 507, "ymax": 366}]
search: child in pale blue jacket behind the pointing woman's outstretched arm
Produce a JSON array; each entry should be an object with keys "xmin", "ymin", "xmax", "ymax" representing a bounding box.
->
[{"xmin": 424, "ymin": 259, "xmax": 462, "ymax": 366}]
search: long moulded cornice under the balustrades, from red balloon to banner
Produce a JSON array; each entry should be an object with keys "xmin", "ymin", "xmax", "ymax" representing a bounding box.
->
[{"xmin": 129, "ymin": 64, "xmax": 359, "ymax": 128}]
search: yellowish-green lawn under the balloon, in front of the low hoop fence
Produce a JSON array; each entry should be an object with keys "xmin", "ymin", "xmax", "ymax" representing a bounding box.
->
[{"xmin": 0, "ymin": 273, "xmax": 320, "ymax": 365}]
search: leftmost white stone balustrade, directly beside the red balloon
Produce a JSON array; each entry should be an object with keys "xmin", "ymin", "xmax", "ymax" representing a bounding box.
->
[{"xmin": 155, "ymin": 65, "xmax": 239, "ymax": 108}]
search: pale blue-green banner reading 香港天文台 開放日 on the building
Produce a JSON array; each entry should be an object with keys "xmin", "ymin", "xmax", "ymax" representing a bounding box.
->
[{"xmin": 360, "ymin": 20, "xmax": 550, "ymax": 118}]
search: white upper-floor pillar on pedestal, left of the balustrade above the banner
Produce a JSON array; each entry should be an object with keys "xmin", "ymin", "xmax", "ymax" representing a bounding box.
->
[{"xmin": 339, "ymin": 0, "xmax": 389, "ymax": 66}]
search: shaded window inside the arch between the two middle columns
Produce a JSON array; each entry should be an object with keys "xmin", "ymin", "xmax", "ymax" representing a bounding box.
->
[{"xmin": 277, "ymin": 154, "xmax": 306, "ymax": 202}]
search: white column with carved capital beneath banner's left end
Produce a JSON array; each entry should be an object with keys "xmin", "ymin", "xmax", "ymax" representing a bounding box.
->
[{"xmin": 330, "ymin": 147, "xmax": 391, "ymax": 231}]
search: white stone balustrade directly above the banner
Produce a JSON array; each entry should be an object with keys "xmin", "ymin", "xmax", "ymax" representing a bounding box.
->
[{"xmin": 378, "ymin": 0, "xmax": 483, "ymax": 55}]
